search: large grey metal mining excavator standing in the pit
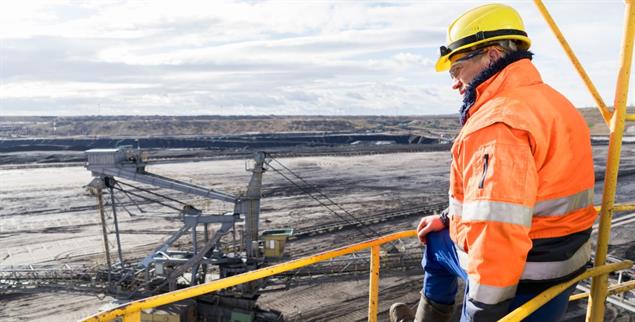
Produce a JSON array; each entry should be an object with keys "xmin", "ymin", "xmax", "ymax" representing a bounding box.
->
[{"xmin": 86, "ymin": 146, "xmax": 290, "ymax": 321}]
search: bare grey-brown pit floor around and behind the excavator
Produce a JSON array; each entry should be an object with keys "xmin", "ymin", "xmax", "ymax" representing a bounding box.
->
[{"xmin": 0, "ymin": 145, "xmax": 635, "ymax": 321}]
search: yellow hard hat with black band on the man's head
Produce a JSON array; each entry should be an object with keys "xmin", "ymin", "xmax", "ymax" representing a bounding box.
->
[{"xmin": 436, "ymin": 4, "xmax": 531, "ymax": 72}]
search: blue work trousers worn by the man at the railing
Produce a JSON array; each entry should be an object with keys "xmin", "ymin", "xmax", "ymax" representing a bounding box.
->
[{"xmin": 421, "ymin": 229, "xmax": 575, "ymax": 322}]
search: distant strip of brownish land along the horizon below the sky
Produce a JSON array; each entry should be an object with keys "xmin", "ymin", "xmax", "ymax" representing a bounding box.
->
[{"xmin": 0, "ymin": 107, "xmax": 635, "ymax": 139}]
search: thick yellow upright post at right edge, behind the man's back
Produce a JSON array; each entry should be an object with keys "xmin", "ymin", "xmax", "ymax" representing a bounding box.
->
[{"xmin": 586, "ymin": 0, "xmax": 635, "ymax": 322}]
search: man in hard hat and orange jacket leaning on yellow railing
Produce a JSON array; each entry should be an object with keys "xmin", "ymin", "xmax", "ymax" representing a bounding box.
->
[{"xmin": 390, "ymin": 4, "xmax": 597, "ymax": 322}]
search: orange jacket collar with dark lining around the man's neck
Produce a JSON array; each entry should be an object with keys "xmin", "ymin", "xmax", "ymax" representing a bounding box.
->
[{"xmin": 460, "ymin": 50, "xmax": 542, "ymax": 125}]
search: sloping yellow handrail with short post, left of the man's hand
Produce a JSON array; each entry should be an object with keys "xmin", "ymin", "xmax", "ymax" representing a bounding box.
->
[{"xmin": 83, "ymin": 230, "xmax": 417, "ymax": 322}]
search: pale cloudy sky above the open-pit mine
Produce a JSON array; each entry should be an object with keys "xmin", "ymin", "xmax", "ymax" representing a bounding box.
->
[{"xmin": 0, "ymin": 0, "xmax": 635, "ymax": 116}]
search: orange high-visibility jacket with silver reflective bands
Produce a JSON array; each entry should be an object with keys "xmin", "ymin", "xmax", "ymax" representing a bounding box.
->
[{"xmin": 449, "ymin": 59, "xmax": 597, "ymax": 305}]
